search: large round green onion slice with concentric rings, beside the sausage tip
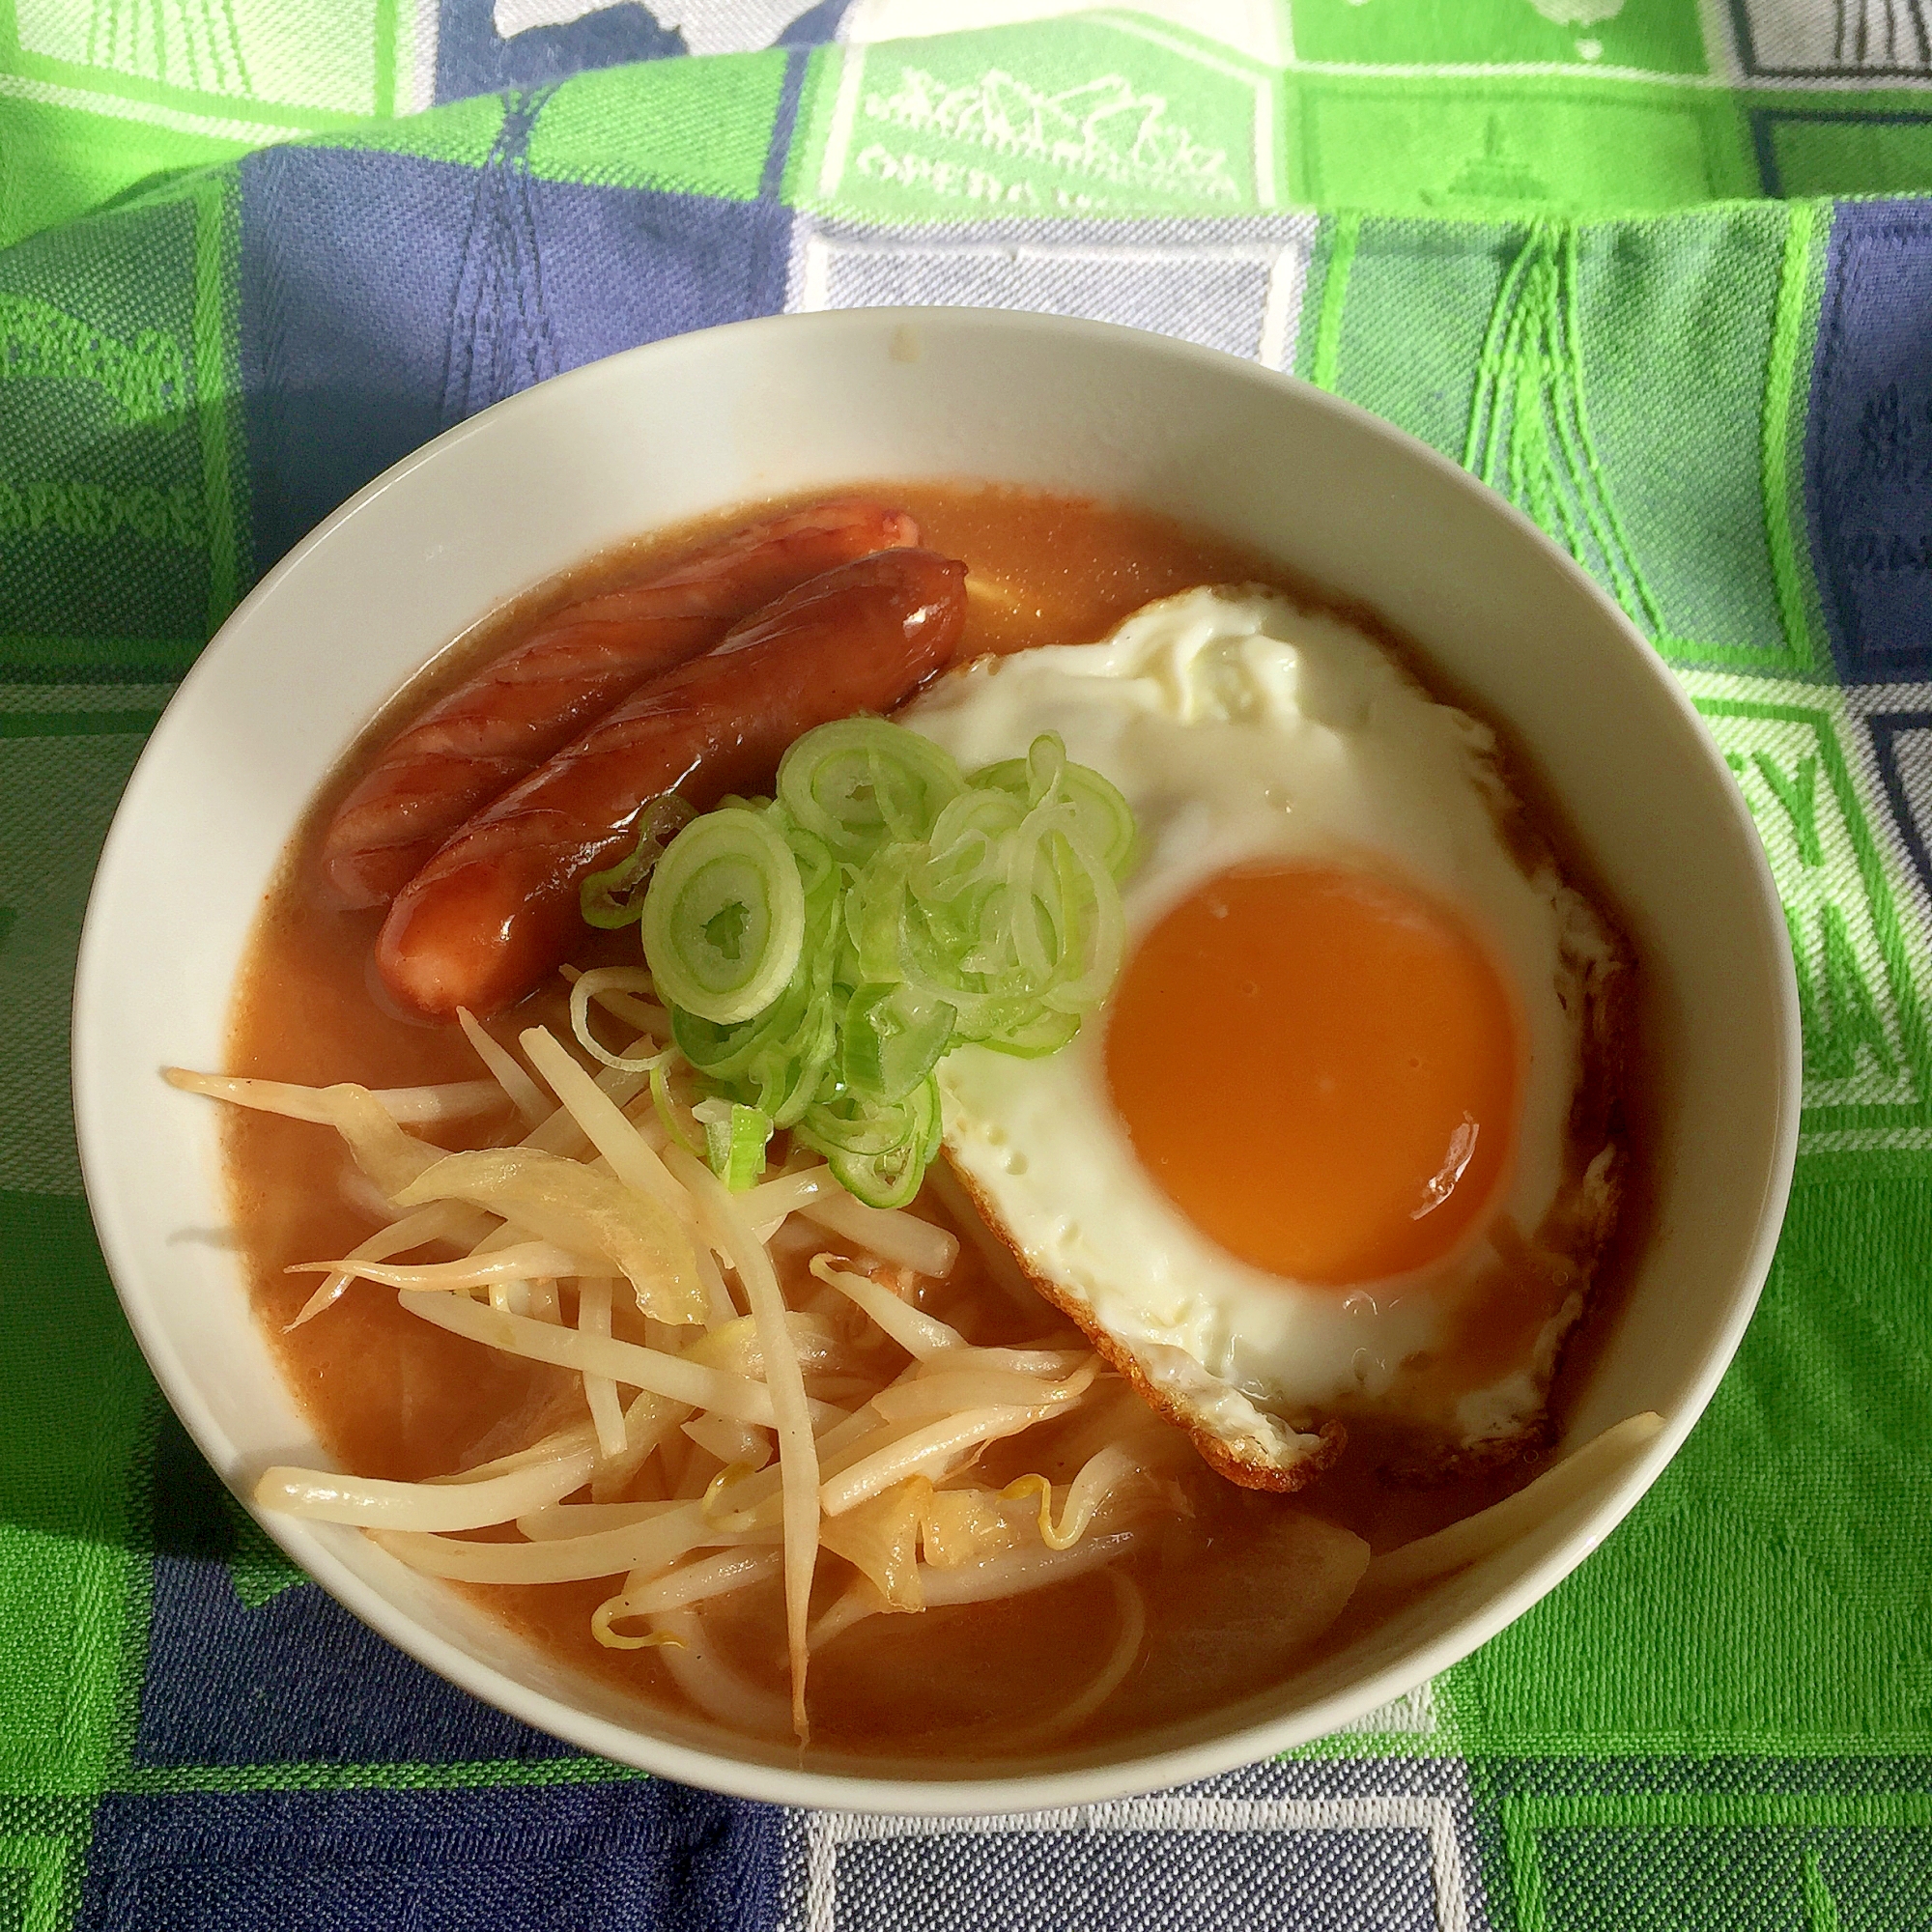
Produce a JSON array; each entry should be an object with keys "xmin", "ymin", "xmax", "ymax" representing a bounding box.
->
[{"xmin": 643, "ymin": 810, "xmax": 806, "ymax": 1026}]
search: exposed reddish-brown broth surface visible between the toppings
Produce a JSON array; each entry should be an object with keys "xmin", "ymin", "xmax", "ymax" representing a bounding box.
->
[{"xmin": 228, "ymin": 485, "xmax": 1629, "ymax": 1756}]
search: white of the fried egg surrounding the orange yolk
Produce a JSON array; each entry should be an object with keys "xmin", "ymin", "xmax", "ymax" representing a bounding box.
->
[{"xmin": 902, "ymin": 587, "xmax": 1605, "ymax": 1459}]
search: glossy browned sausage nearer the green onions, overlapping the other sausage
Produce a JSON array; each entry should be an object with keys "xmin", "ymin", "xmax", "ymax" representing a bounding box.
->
[{"xmin": 377, "ymin": 551, "xmax": 966, "ymax": 1018}]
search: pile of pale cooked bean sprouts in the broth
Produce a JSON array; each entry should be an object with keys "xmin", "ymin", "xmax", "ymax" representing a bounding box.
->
[{"xmin": 168, "ymin": 966, "xmax": 1192, "ymax": 1743}]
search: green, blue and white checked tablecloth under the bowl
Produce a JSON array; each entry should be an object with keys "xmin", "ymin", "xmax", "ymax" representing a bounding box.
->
[{"xmin": 0, "ymin": 0, "xmax": 1932, "ymax": 1932}]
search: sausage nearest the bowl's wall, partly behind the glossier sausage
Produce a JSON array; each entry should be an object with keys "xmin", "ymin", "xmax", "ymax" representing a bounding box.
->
[{"xmin": 321, "ymin": 498, "xmax": 920, "ymax": 906}]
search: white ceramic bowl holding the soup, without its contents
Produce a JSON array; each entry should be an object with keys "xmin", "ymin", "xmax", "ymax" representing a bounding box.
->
[{"xmin": 73, "ymin": 309, "xmax": 1799, "ymax": 1812}]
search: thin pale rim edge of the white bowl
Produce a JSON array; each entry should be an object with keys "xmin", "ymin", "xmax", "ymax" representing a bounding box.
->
[{"xmin": 70, "ymin": 307, "xmax": 1803, "ymax": 1816}]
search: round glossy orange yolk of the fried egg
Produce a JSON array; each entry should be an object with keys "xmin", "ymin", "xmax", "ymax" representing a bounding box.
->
[{"xmin": 1107, "ymin": 866, "xmax": 1524, "ymax": 1287}]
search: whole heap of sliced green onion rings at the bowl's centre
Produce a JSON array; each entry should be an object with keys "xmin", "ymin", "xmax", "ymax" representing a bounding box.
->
[{"xmin": 585, "ymin": 719, "xmax": 1134, "ymax": 1208}]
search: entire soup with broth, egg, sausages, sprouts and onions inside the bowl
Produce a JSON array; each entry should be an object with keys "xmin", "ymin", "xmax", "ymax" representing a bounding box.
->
[{"xmin": 192, "ymin": 485, "xmax": 1654, "ymax": 1758}]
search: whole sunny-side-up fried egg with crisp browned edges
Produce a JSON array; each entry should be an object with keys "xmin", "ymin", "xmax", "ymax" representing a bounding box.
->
[{"xmin": 902, "ymin": 587, "xmax": 1621, "ymax": 1488}]
